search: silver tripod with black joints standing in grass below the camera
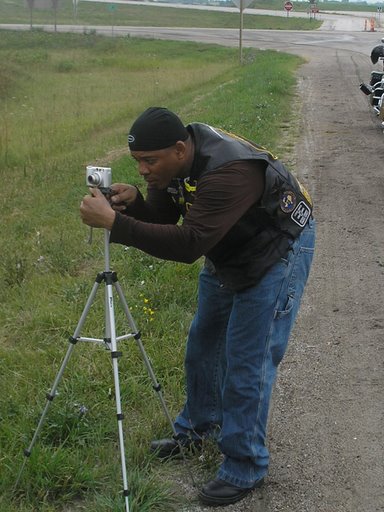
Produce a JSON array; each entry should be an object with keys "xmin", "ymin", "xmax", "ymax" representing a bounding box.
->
[{"xmin": 16, "ymin": 230, "xmax": 185, "ymax": 512}]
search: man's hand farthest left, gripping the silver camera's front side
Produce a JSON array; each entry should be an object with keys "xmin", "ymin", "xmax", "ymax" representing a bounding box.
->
[{"xmin": 80, "ymin": 188, "xmax": 116, "ymax": 231}]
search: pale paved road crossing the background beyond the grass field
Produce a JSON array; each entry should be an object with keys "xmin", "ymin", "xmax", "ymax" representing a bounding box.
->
[{"xmin": 0, "ymin": 6, "xmax": 384, "ymax": 55}]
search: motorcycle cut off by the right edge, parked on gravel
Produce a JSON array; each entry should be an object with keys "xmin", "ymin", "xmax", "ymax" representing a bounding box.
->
[{"xmin": 360, "ymin": 38, "xmax": 384, "ymax": 128}]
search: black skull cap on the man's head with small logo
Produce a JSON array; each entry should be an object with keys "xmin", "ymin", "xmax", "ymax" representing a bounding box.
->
[{"xmin": 128, "ymin": 107, "xmax": 189, "ymax": 151}]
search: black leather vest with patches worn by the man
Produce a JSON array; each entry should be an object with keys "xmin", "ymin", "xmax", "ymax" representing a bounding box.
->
[{"xmin": 168, "ymin": 123, "xmax": 312, "ymax": 290}]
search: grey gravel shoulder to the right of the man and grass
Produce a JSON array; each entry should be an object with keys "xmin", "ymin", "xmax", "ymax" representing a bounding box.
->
[{"xmin": 180, "ymin": 43, "xmax": 384, "ymax": 512}]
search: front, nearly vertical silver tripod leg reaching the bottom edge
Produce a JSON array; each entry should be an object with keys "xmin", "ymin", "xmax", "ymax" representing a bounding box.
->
[{"xmin": 105, "ymin": 272, "xmax": 129, "ymax": 512}]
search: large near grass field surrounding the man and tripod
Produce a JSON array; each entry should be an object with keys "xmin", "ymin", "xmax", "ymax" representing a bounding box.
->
[{"xmin": 0, "ymin": 19, "xmax": 301, "ymax": 512}]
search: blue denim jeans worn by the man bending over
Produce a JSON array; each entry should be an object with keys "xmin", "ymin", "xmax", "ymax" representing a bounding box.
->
[{"xmin": 175, "ymin": 220, "xmax": 315, "ymax": 488}]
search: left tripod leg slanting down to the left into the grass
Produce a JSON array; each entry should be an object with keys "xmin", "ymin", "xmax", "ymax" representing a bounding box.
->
[{"xmin": 15, "ymin": 274, "xmax": 104, "ymax": 488}]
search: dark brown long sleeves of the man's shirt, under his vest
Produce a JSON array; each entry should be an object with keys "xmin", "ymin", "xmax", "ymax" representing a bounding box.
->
[{"xmin": 110, "ymin": 161, "xmax": 265, "ymax": 263}]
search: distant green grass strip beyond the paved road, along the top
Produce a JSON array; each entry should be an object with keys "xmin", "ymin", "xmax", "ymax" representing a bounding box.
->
[{"xmin": 0, "ymin": 0, "xmax": 321, "ymax": 30}]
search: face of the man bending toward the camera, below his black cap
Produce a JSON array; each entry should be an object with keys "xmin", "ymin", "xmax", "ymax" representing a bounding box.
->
[{"xmin": 131, "ymin": 143, "xmax": 185, "ymax": 189}]
